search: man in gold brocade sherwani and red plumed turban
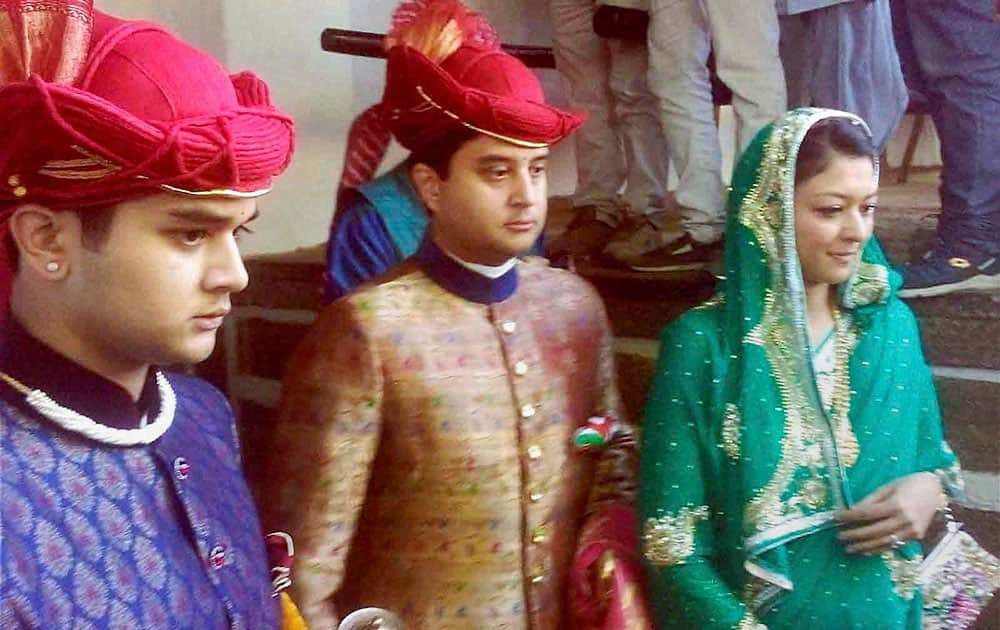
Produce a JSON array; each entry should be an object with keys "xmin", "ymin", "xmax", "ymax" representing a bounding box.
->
[{"xmin": 265, "ymin": 0, "xmax": 635, "ymax": 629}]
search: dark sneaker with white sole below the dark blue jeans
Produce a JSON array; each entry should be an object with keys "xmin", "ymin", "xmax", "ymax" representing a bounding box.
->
[{"xmin": 899, "ymin": 246, "xmax": 1000, "ymax": 298}]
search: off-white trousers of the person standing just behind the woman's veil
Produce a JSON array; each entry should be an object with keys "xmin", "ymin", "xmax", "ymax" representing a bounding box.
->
[{"xmin": 649, "ymin": 0, "xmax": 786, "ymax": 242}]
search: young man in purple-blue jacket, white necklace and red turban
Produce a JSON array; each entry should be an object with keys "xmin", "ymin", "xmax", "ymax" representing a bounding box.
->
[{"xmin": 0, "ymin": 0, "xmax": 294, "ymax": 628}]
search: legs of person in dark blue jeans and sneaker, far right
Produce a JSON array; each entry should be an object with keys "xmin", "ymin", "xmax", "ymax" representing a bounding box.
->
[{"xmin": 891, "ymin": 0, "xmax": 1000, "ymax": 297}]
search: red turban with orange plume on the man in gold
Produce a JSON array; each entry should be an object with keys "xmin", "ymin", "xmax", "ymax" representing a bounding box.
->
[{"xmin": 340, "ymin": 0, "xmax": 585, "ymax": 194}]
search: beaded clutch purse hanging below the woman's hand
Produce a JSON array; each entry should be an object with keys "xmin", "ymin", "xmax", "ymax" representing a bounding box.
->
[{"xmin": 917, "ymin": 510, "xmax": 1000, "ymax": 630}]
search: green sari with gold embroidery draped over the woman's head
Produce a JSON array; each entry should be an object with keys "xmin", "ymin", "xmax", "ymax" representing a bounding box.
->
[{"xmin": 639, "ymin": 109, "xmax": 958, "ymax": 630}]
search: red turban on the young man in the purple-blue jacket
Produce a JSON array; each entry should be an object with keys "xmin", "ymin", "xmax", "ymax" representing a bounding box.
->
[{"xmin": 0, "ymin": 0, "xmax": 295, "ymax": 304}]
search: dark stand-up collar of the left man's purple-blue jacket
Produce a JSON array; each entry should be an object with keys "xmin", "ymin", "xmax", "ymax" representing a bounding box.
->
[{"xmin": 0, "ymin": 312, "xmax": 160, "ymax": 429}]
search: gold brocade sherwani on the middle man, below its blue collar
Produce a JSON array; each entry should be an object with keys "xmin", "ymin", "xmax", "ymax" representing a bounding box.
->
[{"xmin": 266, "ymin": 261, "xmax": 636, "ymax": 630}]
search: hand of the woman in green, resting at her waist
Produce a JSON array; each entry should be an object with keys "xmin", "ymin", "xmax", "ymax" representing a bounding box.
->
[{"xmin": 835, "ymin": 472, "xmax": 944, "ymax": 554}]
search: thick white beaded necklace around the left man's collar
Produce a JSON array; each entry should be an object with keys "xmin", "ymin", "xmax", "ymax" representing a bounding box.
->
[{"xmin": 0, "ymin": 370, "xmax": 177, "ymax": 446}]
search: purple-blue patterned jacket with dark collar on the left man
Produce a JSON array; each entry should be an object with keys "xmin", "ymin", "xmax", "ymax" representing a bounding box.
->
[{"xmin": 0, "ymin": 323, "xmax": 280, "ymax": 630}]
